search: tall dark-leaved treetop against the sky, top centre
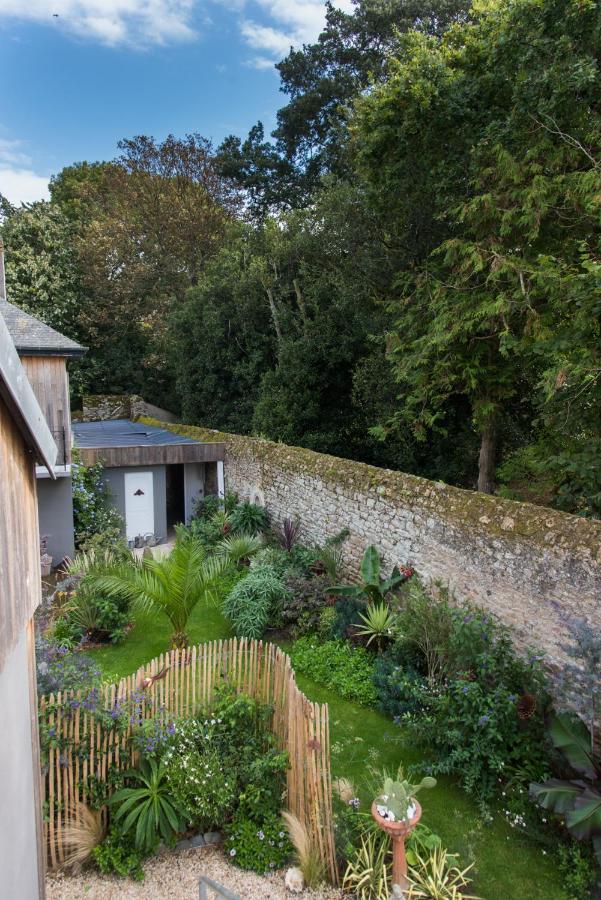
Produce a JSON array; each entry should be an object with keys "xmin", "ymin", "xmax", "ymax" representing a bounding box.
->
[{"xmin": 220, "ymin": 0, "xmax": 471, "ymax": 206}]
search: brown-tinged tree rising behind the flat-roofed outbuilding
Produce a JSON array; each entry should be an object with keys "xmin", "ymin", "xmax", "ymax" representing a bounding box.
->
[{"xmin": 45, "ymin": 134, "xmax": 238, "ymax": 405}]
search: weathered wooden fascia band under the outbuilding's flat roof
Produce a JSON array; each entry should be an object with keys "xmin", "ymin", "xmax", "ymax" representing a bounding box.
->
[{"xmin": 79, "ymin": 442, "xmax": 225, "ymax": 469}]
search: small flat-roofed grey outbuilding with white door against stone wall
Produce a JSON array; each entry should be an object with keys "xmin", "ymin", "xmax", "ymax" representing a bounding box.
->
[{"xmin": 73, "ymin": 419, "xmax": 225, "ymax": 541}]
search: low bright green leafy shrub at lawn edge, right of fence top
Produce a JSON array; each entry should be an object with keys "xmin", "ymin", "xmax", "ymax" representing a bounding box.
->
[{"xmin": 290, "ymin": 637, "xmax": 376, "ymax": 706}]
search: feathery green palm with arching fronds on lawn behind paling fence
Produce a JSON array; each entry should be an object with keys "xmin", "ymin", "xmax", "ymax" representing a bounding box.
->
[{"xmin": 87, "ymin": 538, "xmax": 231, "ymax": 648}]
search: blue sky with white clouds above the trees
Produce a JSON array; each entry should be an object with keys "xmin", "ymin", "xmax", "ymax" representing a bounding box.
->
[{"xmin": 0, "ymin": 0, "xmax": 352, "ymax": 204}]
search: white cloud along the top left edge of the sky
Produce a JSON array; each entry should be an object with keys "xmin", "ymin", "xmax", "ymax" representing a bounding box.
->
[{"xmin": 0, "ymin": 0, "xmax": 195, "ymax": 46}]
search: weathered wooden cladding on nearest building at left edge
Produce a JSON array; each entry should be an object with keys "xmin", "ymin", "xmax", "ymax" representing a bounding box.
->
[{"xmin": 0, "ymin": 399, "xmax": 42, "ymax": 671}]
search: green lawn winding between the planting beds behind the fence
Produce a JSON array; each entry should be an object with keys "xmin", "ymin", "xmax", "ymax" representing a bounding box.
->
[{"xmin": 92, "ymin": 604, "xmax": 567, "ymax": 900}]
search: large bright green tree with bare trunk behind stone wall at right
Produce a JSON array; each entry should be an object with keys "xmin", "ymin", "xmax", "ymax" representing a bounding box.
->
[{"xmin": 354, "ymin": 0, "xmax": 600, "ymax": 500}]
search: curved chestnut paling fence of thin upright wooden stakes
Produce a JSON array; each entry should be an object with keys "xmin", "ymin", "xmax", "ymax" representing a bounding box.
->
[{"xmin": 39, "ymin": 638, "xmax": 338, "ymax": 883}]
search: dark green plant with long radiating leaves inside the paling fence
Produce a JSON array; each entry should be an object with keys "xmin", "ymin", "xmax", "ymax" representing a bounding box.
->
[{"xmin": 109, "ymin": 759, "xmax": 184, "ymax": 852}]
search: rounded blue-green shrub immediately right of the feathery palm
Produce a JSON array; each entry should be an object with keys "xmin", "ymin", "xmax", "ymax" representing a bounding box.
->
[{"xmin": 223, "ymin": 566, "xmax": 288, "ymax": 638}]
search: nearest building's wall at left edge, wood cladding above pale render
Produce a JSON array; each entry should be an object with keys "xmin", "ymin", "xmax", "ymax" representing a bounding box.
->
[{"xmin": 0, "ymin": 400, "xmax": 44, "ymax": 900}]
